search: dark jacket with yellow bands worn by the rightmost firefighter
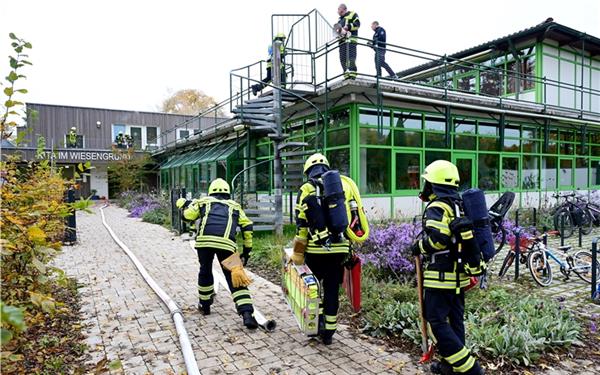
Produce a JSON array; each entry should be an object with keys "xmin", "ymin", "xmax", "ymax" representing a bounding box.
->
[{"xmin": 419, "ymin": 185, "xmax": 473, "ymax": 289}]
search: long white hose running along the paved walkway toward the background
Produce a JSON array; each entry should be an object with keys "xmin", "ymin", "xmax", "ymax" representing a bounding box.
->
[{"xmin": 100, "ymin": 205, "xmax": 200, "ymax": 375}]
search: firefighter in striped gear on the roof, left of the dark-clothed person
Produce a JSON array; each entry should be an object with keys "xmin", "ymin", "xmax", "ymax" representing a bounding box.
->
[{"xmin": 335, "ymin": 4, "xmax": 360, "ymax": 79}]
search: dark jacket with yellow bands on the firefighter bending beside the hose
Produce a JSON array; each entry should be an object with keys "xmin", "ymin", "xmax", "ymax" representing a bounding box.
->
[{"xmin": 183, "ymin": 196, "xmax": 252, "ymax": 252}]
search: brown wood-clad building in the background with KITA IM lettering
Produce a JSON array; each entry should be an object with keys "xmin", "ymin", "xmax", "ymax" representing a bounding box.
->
[{"xmin": 3, "ymin": 103, "xmax": 219, "ymax": 197}]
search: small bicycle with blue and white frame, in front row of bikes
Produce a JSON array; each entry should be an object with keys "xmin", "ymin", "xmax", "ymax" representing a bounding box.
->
[{"xmin": 527, "ymin": 234, "xmax": 600, "ymax": 286}]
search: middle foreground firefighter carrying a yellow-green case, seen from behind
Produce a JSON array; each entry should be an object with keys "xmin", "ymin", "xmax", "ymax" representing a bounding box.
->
[{"xmin": 291, "ymin": 153, "xmax": 358, "ymax": 345}]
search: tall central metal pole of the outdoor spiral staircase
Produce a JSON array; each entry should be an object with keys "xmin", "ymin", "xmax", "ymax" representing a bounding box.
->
[{"xmin": 272, "ymin": 40, "xmax": 283, "ymax": 236}]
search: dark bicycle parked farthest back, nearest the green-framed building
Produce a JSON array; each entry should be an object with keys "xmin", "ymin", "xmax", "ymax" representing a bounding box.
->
[{"xmin": 552, "ymin": 193, "xmax": 593, "ymax": 238}]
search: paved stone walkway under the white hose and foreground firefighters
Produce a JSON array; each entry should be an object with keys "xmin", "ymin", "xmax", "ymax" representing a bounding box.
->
[{"xmin": 56, "ymin": 207, "xmax": 422, "ymax": 375}]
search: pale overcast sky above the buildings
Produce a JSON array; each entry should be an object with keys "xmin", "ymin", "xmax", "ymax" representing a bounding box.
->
[{"xmin": 0, "ymin": 0, "xmax": 600, "ymax": 111}]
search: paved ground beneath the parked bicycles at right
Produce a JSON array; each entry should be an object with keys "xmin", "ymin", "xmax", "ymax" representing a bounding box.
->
[{"xmin": 492, "ymin": 228, "xmax": 600, "ymax": 316}]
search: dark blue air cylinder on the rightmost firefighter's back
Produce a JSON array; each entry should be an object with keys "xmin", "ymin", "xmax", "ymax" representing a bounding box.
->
[{"xmin": 462, "ymin": 189, "xmax": 496, "ymax": 262}]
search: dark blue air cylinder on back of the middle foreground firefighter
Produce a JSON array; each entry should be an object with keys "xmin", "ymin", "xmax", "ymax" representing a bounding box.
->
[{"xmin": 321, "ymin": 170, "xmax": 348, "ymax": 235}]
